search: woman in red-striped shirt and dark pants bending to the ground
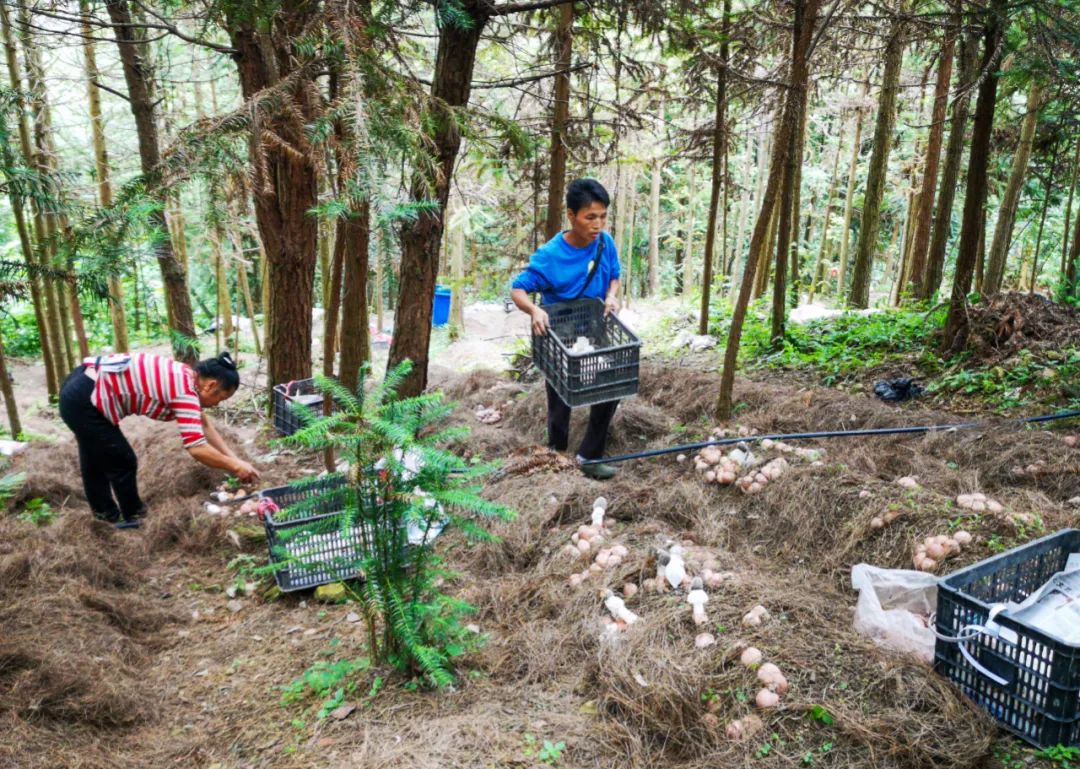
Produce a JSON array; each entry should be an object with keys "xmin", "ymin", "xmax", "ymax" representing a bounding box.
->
[{"xmin": 59, "ymin": 352, "xmax": 259, "ymax": 528}]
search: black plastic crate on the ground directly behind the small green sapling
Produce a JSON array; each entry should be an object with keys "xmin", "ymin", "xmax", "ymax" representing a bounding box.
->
[{"xmin": 261, "ymin": 475, "xmax": 363, "ymax": 593}]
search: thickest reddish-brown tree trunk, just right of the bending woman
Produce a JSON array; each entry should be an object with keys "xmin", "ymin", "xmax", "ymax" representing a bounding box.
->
[{"xmin": 227, "ymin": 8, "xmax": 321, "ymax": 387}]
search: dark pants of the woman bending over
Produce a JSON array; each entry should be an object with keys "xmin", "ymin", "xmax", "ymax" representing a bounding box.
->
[{"xmin": 60, "ymin": 366, "xmax": 145, "ymax": 523}]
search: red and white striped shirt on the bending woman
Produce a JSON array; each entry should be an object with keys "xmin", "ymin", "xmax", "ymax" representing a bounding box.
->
[{"xmin": 83, "ymin": 353, "xmax": 206, "ymax": 448}]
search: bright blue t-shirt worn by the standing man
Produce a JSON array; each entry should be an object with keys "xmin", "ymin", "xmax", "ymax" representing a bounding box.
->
[{"xmin": 512, "ymin": 232, "xmax": 620, "ymax": 305}]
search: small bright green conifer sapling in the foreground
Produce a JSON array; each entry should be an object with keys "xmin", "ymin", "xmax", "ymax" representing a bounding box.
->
[{"xmin": 279, "ymin": 361, "xmax": 514, "ymax": 687}]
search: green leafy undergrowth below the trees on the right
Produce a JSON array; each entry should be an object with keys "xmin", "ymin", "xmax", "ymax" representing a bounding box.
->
[{"xmin": 695, "ymin": 302, "xmax": 1080, "ymax": 413}]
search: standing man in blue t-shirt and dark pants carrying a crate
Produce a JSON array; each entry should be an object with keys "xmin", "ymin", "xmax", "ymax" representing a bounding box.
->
[{"xmin": 510, "ymin": 179, "xmax": 620, "ymax": 481}]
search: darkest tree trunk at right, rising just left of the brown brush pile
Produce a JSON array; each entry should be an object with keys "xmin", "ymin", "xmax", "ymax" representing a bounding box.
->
[{"xmin": 942, "ymin": 0, "xmax": 1007, "ymax": 352}]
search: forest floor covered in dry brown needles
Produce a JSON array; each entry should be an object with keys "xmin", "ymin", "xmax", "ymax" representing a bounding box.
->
[{"xmin": 0, "ymin": 298, "xmax": 1080, "ymax": 769}]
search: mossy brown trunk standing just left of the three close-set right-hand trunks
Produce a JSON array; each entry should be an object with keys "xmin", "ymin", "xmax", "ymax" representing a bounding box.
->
[{"xmin": 848, "ymin": 18, "xmax": 906, "ymax": 308}]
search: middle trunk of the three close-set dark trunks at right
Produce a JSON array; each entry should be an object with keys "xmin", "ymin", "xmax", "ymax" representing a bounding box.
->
[{"xmin": 915, "ymin": 33, "xmax": 978, "ymax": 301}]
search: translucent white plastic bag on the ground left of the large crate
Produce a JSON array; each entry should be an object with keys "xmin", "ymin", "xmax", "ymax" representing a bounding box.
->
[{"xmin": 851, "ymin": 564, "xmax": 937, "ymax": 662}]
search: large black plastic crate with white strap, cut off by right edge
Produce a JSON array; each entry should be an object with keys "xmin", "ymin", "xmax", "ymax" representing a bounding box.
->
[{"xmin": 934, "ymin": 529, "xmax": 1080, "ymax": 747}]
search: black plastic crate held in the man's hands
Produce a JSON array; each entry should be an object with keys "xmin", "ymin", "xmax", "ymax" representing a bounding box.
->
[{"xmin": 532, "ymin": 299, "xmax": 642, "ymax": 406}]
